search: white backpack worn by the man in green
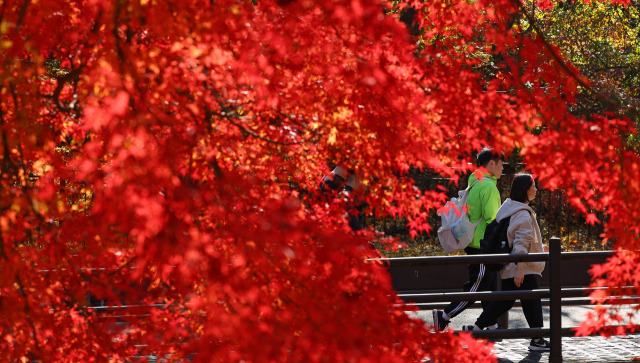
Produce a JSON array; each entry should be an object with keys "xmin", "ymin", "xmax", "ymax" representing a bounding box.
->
[{"xmin": 438, "ymin": 178, "xmax": 486, "ymax": 253}]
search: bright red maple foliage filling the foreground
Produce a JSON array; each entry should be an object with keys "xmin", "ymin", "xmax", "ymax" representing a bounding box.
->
[{"xmin": 0, "ymin": 0, "xmax": 640, "ymax": 362}]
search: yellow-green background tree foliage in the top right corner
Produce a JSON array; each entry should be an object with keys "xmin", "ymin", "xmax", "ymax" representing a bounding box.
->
[{"xmin": 522, "ymin": 1, "xmax": 640, "ymax": 144}]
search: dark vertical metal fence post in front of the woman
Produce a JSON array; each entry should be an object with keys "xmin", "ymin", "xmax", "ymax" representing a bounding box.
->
[{"xmin": 549, "ymin": 237, "xmax": 562, "ymax": 363}]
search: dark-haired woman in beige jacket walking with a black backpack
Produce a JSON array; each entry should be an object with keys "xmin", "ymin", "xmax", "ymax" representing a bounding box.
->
[{"xmin": 462, "ymin": 174, "xmax": 550, "ymax": 351}]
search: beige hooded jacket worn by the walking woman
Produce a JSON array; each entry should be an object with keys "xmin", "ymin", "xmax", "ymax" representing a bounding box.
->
[{"xmin": 496, "ymin": 198, "xmax": 545, "ymax": 279}]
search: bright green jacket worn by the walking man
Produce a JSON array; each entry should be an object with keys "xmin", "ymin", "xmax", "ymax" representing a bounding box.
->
[{"xmin": 467, "ymin": 170, "xmax": 500, "ymax": 249}]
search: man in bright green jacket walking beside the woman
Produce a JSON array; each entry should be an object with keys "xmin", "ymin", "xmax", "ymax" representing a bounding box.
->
[{"xmin": 433, "ymin": 148, "xmax": 504, "ymax": 330}]
